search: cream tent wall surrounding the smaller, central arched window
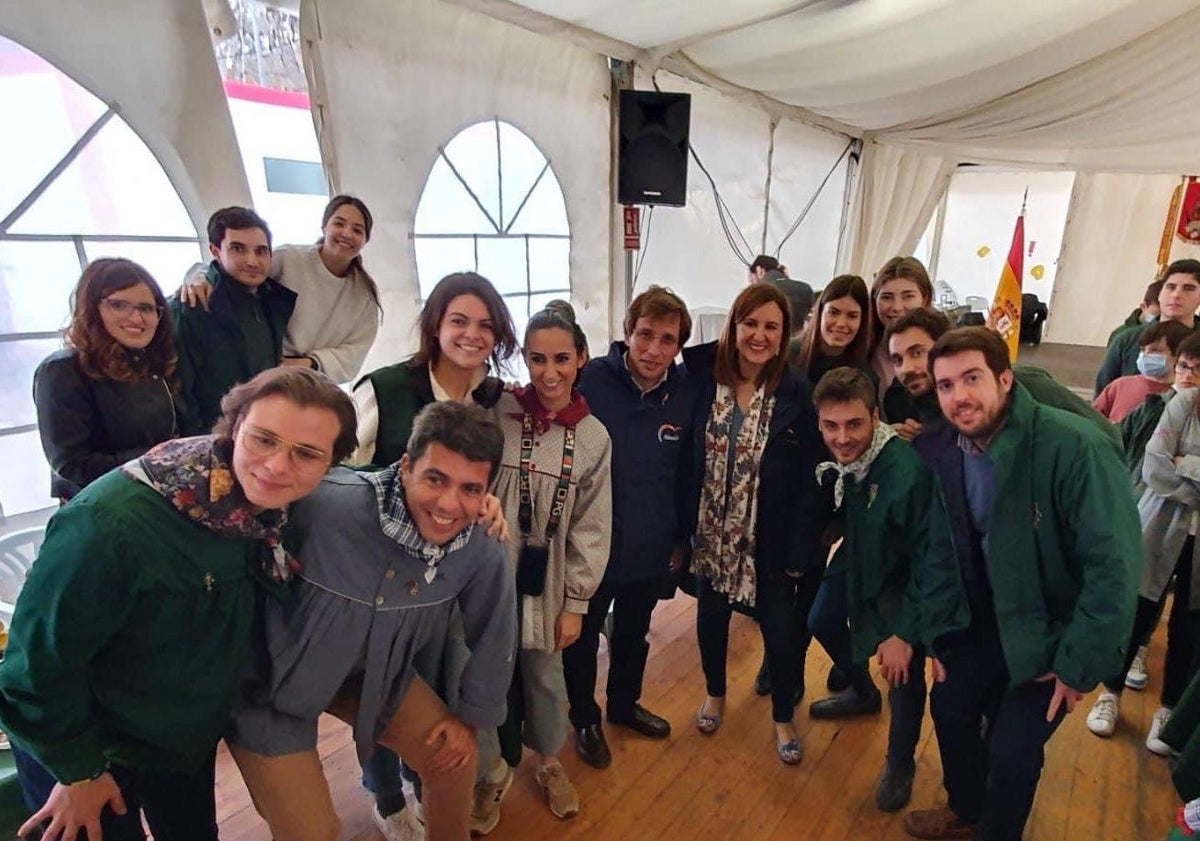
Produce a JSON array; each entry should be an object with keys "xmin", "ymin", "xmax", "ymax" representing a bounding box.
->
[{"xmin": 301, "ymin": 0, "xmax": 611, "ymax": 370}]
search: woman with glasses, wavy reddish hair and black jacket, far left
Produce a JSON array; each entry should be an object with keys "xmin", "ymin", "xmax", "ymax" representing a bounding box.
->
[{"xmin": 34, "ymin": 259, "xmax": 178, "ymax": 501}]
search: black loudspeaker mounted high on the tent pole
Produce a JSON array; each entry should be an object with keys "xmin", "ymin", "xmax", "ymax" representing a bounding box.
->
[{"xmin": 617, "ymin": 90, "xmax": 691, "ymax": 208}]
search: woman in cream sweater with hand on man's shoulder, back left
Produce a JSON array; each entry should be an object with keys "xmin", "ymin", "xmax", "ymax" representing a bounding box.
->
[{"xmin": 179, "ymin": 196, "xmax": 382, "ymax": 383}]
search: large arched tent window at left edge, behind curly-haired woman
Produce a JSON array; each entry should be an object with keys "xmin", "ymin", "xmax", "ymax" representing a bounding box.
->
[{"xmin": 0, "ymin": 37, "xmax": 203, "ymax": 531}]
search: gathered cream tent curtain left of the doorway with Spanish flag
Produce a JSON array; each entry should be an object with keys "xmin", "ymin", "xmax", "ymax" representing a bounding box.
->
[{"xmin": 847, "ymin": 140, "xmax": 956, "ymax": 278}]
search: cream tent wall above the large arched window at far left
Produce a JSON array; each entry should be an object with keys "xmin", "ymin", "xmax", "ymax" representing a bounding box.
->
[{"xmin": 0, "ymin": 0, "xmax": 251, "ymax": 241}]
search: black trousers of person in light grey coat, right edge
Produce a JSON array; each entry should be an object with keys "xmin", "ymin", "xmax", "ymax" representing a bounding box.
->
[{"xmin": 1104, "ymin": 536, "xmax": 1200, "ymax": 708}]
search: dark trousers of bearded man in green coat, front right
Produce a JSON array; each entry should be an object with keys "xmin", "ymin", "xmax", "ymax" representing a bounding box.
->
[{"xmin": 929, "ymin": 632, "xmax": 1067, "ymax": 841}]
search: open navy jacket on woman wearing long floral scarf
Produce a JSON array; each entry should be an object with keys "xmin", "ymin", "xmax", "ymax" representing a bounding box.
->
[{"xmin": 681, "ymin": 342, "xmax": 828, "ymax": 575}]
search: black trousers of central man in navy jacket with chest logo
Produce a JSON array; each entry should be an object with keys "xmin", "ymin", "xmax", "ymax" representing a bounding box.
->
[{"xmin": 563, "ymin": 578, "xmax": 662, "ymax": 728}]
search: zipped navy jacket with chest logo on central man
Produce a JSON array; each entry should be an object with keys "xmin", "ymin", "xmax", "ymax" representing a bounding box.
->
[{"xmin": 580, "ymin": 342, "xmax": 692, "ymax": 584}]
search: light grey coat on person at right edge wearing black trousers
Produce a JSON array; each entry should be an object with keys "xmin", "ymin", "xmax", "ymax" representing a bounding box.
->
[{"xmin": 1138, "ymin": 389, "xmax": 1200, "ymax": 609}]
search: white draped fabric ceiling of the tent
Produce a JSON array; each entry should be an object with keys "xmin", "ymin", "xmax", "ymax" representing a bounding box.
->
[{"xmin": 454, "ymin": 0, "xmax": 1200, "ymax": 172}]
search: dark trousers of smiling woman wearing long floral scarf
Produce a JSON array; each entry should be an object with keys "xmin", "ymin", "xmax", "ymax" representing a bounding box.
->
[{"xmin": 696, "ymin": 572, "xmax": 821, "ymax": 723}]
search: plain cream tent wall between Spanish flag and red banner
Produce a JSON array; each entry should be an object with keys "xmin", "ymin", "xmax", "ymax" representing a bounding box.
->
[{"xmin": 1044, "ymin": 174, "xmax": 1200, "ymax": 347}]
